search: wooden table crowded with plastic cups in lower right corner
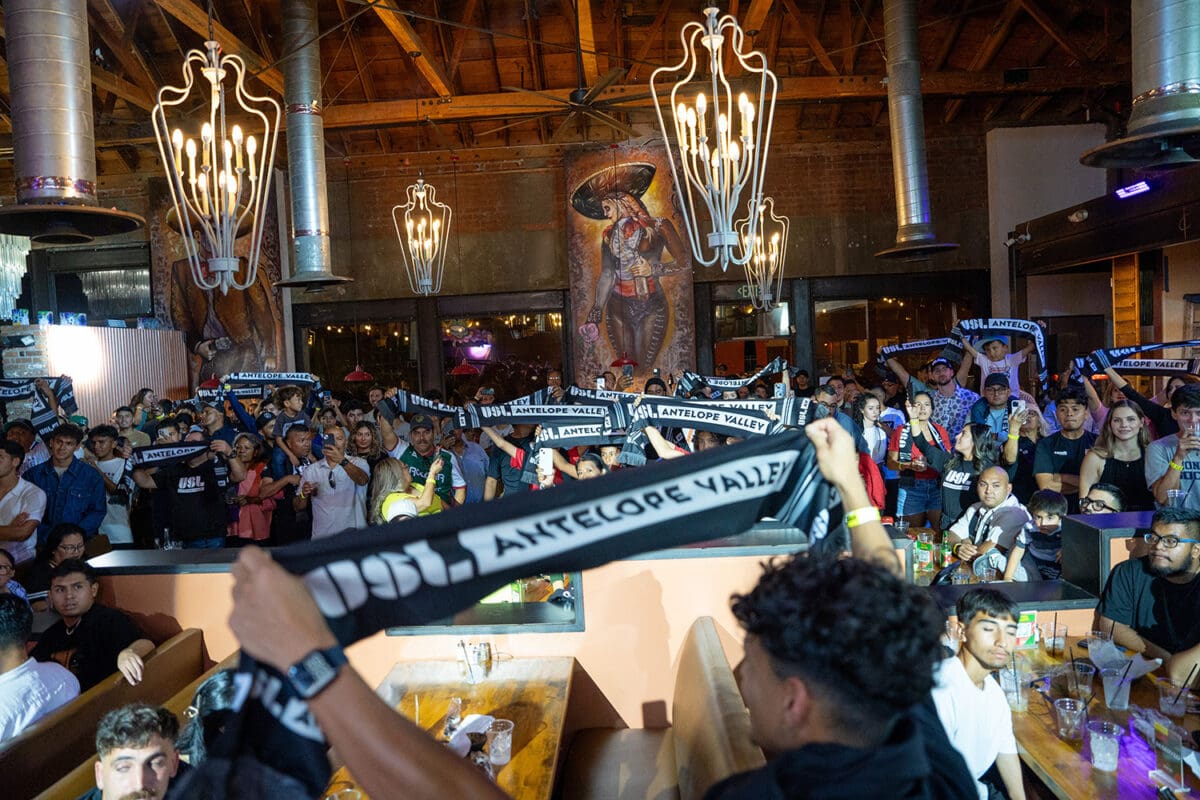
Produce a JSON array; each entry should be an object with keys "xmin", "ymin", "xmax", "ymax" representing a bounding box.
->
[{"xmin": 1013, "ymin": 637, "xmax": 1200, "ymax": 800}]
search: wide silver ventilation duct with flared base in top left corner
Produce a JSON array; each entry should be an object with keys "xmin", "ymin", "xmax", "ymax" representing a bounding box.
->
[{"xmin": 0, "ymin": 0, "xmax": 145, "ymax": 245}]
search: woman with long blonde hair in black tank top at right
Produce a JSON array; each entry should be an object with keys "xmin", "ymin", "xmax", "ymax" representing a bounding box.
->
[{"xmin": 1079, "ymin": 399, "xmax": 1154, "ymax": 511}]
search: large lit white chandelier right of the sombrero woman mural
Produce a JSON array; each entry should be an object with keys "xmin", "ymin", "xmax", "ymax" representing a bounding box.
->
[{"xmin": 650, "ymin": 8, "xmax": 778, "ymax": 271}]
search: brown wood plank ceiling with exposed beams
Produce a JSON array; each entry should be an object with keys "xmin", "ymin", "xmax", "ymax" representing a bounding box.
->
[{"xmin": 0, "ymin": 0, "xmax": 1129, "ymax": 180}]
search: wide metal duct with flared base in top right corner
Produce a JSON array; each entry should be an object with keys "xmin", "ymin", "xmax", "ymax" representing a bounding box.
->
[{"xmin": 1079, "ymin": 0, "xmax": 1200, "ymax": 169}]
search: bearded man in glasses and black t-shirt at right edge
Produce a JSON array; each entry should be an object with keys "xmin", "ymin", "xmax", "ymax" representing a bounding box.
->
[{"xmin": 1093, "ymin": 509, "xmax": 1200, "ymax": 681}]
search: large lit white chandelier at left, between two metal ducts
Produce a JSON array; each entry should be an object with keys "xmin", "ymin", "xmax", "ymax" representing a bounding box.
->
[{"xmin": 151, "ymin": 41, "xmax": 280, "ymax": 294}]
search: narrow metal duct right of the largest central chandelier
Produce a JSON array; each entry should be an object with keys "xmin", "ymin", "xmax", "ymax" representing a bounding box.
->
[{"xmin": 875, "ymin": 0, "xmax": 958, "ymax": 258}]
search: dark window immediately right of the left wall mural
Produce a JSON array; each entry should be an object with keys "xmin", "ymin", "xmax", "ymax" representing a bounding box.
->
[{"xmin": 306, "ymin": 319, "xmax": 420, "ymax": 391}]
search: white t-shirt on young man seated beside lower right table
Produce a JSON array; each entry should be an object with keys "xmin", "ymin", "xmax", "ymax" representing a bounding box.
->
[{"xmin": 934, "ymin": 656, "xmax": 1016, "ymax": 800}]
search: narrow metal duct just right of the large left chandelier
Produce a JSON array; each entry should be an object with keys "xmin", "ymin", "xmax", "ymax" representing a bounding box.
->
[{"xmin": 273, "ymin": 0, "xmax": 350, "ymax": 291}]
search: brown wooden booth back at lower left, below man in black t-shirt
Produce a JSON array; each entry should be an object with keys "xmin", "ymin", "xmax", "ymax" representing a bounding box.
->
[{"xmin": 0, "ymin": 628, "xmax": 205, "ymax": 798}]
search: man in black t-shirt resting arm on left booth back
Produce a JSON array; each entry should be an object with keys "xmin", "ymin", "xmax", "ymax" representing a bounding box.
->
[{"xmin": 30, "ymin": 559, "xmax": 154, "ymax": 692}]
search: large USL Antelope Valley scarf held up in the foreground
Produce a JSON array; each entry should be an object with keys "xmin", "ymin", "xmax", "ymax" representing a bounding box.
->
[{"xmin": 175, "ymin": 431, "xmax": 842, "ymax": 800}]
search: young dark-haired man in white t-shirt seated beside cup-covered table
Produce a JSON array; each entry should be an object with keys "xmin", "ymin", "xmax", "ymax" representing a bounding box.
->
[{"xmin": 934, "ymin": 589, "xmax": 1025, "ymax": 800}]
